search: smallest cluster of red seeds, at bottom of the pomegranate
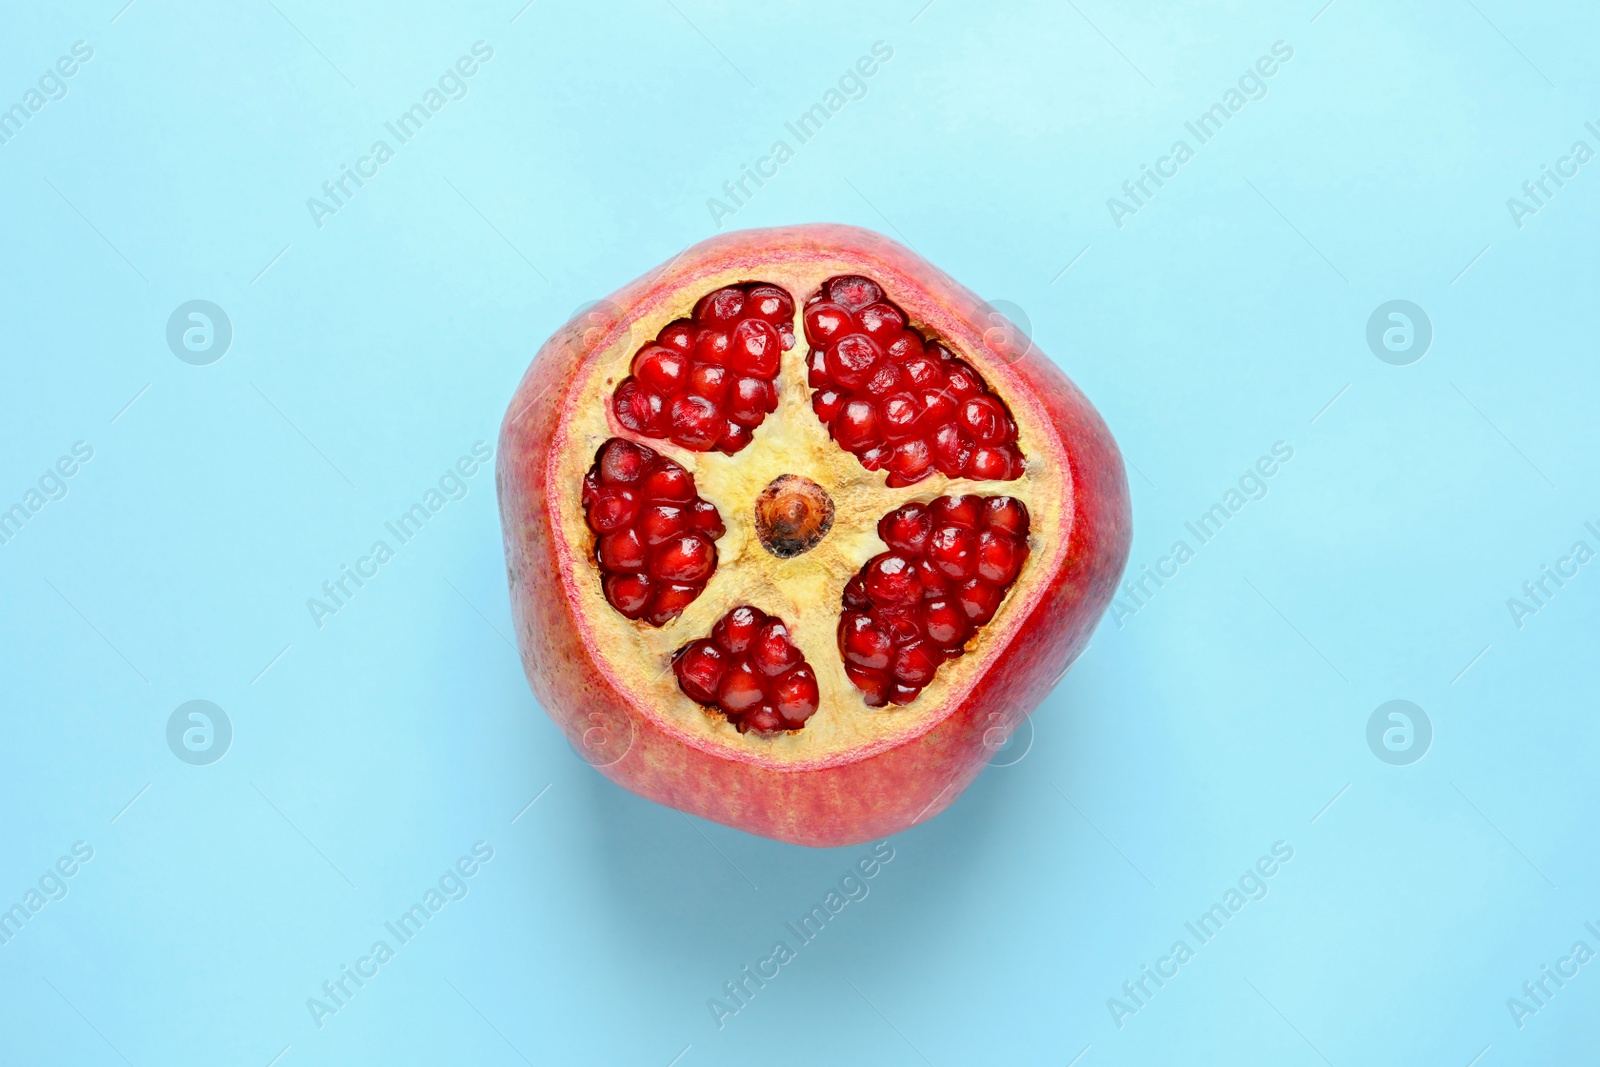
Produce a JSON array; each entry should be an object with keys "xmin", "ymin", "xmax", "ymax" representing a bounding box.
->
[{"xmin": 672, "ymin": 605, "xmax": 821, "ymax": 733}]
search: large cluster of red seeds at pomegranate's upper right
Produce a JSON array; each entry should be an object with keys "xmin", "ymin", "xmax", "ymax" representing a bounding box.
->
[{"xmin": 805, "ymin": 275, "xmax": 1022, "ymax": 486}]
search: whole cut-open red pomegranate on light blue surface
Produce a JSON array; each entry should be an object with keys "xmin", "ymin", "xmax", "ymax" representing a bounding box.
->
[{"xmin": 496, "ymin": 226, "xmax": 1131, "ymax": 846}]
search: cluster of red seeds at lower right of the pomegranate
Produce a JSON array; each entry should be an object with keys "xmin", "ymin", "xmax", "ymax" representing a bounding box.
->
[{"xmin": 838, "ymin": 496, "xmax": 1029, "ymax": 707}]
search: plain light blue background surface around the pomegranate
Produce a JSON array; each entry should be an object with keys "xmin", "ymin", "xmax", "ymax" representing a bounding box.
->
[{"xmin": 0, "ymin": 0, "xmax": 1600, "ymax": 1067}]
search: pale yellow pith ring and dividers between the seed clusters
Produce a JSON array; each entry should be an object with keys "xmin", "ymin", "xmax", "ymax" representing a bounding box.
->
[{"xmin": 546, "ymin": 259, "xmax": 1070, "ymax": 765}]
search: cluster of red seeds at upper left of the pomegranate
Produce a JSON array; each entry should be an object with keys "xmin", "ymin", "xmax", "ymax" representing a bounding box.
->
[{"xmin": 611, "ymin": 282, "xmax": 790, "ymax": 454}]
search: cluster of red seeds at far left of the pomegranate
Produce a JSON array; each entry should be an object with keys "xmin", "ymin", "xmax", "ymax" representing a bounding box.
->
[{"xmin": 582, "ymin": 437, "xmax": 725, "ymax": 625}]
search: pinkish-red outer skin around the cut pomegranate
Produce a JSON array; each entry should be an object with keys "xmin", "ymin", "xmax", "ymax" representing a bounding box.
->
[{"xmin": 496, "ymin": 224, "xmax": 1131, "ymax": 848}]
